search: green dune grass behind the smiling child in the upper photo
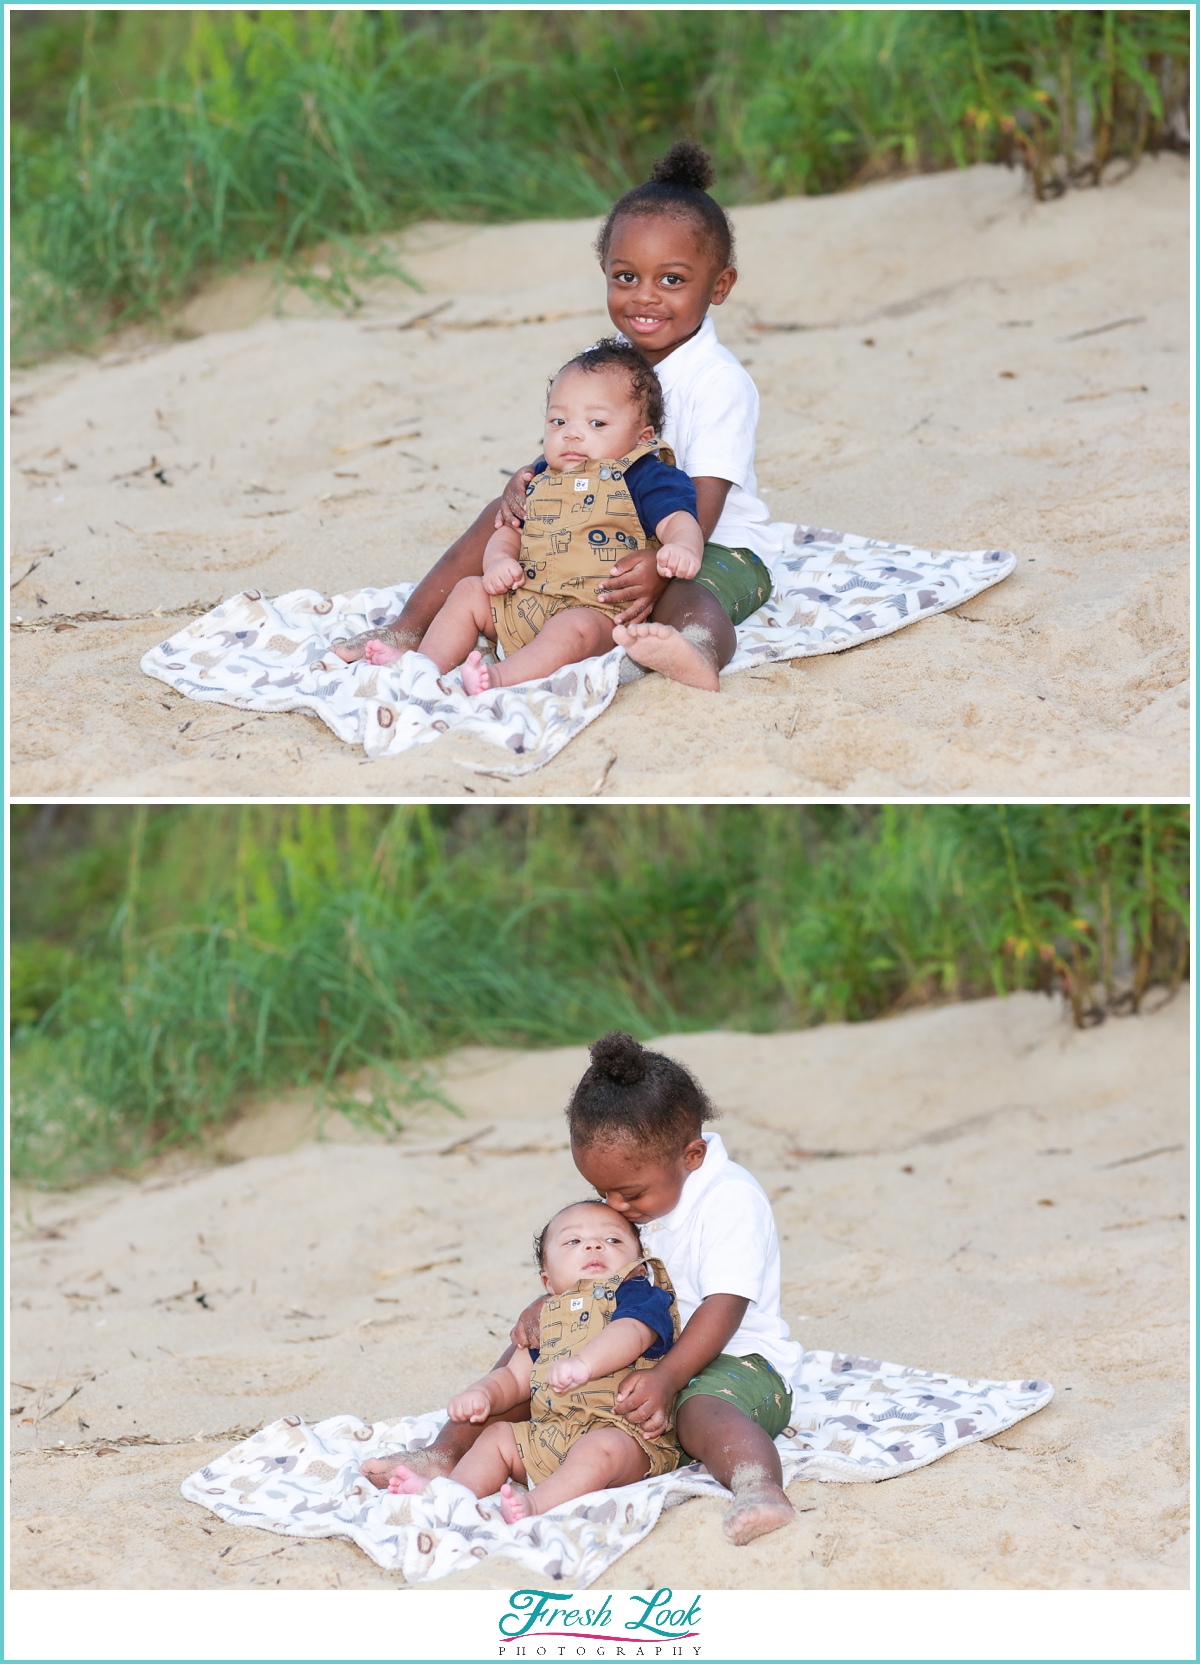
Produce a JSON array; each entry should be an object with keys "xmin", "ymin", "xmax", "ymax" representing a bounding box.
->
[{"xmin": 12, "ymin": 8, "xmax": 1190, "ymax": 356}]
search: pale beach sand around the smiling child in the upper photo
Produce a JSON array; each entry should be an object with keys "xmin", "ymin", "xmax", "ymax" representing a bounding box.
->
[{"xmin": 12, "ymin": 156, "xmax": 1190, "ymax": 799}]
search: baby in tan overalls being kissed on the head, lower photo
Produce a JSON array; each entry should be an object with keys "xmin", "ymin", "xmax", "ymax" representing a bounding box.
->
[{"xmin": 388, "ymin": 1201, "xmax": 681, "ymax": 1524}]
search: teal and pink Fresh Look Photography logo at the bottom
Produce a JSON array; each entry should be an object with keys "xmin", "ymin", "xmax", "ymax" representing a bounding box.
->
[{"xmin": 498, "ymin": 1589, "xmax": 701, "ymax": 1659}]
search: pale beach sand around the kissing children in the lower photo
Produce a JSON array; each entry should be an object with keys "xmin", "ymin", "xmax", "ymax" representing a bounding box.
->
[{"xmin": 10, "ymin": 993, "xmax": 1190, "ymax": 1594}]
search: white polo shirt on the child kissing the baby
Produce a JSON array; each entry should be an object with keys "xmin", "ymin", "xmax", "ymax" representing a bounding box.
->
[{"xmin": 641, "ymin": 1133, "xmax": 804, "ymax": 1386}]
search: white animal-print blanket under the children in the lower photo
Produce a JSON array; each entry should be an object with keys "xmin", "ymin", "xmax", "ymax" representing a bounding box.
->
[{"xmin": 183, "ymin": 1351, "xmax": 1054, "ymax": 1589}]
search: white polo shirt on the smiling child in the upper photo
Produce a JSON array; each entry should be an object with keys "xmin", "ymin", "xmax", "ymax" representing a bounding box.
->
[{"xmin": 632, "ymin": 318, "xmax": 779, "ymax": 559}]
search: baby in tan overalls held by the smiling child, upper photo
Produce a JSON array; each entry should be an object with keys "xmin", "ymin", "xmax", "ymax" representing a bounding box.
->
[{"xmin": 364, "ymin": 339, "xmax": 704, "ymax": 694}]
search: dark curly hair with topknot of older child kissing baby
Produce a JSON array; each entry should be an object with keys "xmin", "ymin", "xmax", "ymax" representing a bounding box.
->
[{"xmin": 566, "ymin": 1030, "xmax": 717, "ymax": 1156}]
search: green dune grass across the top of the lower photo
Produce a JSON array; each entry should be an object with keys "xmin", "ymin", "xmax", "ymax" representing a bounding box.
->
[{"xmin": 12, "ymin": 805, "xmax": 1188, "ymax": 1183}]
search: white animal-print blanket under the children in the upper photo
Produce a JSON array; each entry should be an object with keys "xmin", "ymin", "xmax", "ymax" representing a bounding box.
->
[{"xmin": 141, "ymin": 524, "xmax": 1015, "ymax": 775}]
